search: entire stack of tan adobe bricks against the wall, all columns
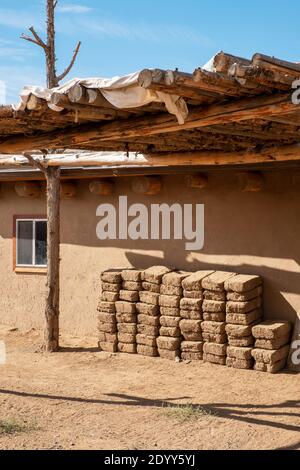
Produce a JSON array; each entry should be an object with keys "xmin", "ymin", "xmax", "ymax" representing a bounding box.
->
[{"xmin": 97, "ymin": 266, "xmax": 291, "ymax": 373}]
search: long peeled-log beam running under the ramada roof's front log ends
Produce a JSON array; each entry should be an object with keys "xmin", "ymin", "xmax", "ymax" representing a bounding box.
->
[{"xmin": 0, "ymin": 93, "xmax": 297, "ymax": 153}]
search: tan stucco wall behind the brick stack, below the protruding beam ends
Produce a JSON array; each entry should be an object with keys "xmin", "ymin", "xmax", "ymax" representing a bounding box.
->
[{"xmin": 0, "ymin": 171, "xmax": 300, "ymax": 335}]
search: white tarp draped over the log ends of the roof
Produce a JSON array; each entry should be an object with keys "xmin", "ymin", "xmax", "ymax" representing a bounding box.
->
[{"xmin": 15, "ymin": 72, "xmax": 188, "ymax": 124}]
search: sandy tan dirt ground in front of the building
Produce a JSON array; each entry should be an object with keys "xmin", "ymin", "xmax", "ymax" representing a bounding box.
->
[{"xmin": 0, "ymin": 327, "xmax": 300, "ymax": 450}]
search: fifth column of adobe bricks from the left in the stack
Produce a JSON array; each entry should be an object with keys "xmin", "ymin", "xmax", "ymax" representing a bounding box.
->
[{"xmin": 180, "ymin": 271, "xmax": 212, "ymax": 361}]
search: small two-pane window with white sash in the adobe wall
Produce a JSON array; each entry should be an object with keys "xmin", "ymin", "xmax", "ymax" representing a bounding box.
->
[{"xmin": 15, "ymin": 218, "xmax": 47, "ymax": 268}]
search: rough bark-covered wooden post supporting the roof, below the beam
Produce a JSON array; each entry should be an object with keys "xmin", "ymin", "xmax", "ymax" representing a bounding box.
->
[{"xmin": 45, "ymin": 168, "xmax": 60, "ymax": 352}]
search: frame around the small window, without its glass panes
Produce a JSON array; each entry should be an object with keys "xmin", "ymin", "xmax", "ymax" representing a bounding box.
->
[{"xmin": 13, "ymin": 215, "xmax": 47, "ymax": 274}]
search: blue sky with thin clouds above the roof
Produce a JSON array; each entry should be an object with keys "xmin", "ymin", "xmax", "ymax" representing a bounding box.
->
[{"xmin": 0, "ymin": 0, "xmax": 300, "ymax": 102}]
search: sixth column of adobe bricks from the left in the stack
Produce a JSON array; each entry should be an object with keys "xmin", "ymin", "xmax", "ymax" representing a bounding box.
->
[{"xmin": 202, "ymin": 271, "xmax": 235, "ymax": 365}]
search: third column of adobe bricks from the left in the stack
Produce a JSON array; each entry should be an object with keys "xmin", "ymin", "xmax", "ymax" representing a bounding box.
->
[{"xmin": 136, "ymin": 266, "xmax": 170, "ymax": 357}]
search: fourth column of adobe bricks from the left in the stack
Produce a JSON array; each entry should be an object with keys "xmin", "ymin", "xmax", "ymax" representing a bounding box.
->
[{"xmin": 157, "ymin": 272, "xmax": 189, "ymax": 360}]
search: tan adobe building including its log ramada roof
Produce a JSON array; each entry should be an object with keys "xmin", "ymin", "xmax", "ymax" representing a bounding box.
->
[{"xmin": 0, "ymin": 53, "xmax": 300, "ymax": 346}]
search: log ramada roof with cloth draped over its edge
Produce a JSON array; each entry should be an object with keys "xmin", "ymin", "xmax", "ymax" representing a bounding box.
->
[{"xmin": 0, "ymin": 52, "xmax": 300, "ymax": 173}]
